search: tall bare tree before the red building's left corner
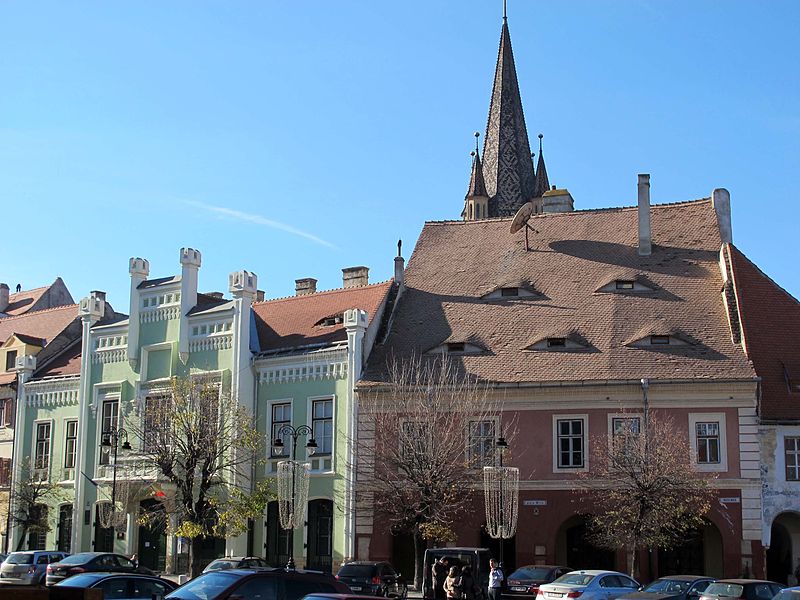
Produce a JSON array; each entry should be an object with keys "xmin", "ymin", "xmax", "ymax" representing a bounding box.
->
[{"xmin": 351, "ymin": 357, "xmax": 503, "ymax": 589}]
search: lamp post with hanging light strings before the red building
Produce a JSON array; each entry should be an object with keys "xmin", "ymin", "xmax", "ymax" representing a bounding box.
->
[{"xmin": 483, "ymin": 437, "xmax": 519, "ymax": 563}]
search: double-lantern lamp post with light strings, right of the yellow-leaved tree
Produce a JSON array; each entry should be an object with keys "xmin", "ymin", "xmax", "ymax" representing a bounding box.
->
[{"xmin": 272, "ymin": 425, "xmax": 317, "ymax": 570}]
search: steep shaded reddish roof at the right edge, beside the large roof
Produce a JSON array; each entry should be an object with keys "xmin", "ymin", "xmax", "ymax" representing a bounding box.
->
[{"xmin": 726, "ymin": 244, "xmax": 800, "ymax": 420}]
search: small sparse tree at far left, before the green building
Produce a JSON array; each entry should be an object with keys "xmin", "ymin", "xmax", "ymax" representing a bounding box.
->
[{"xmin": 11, "ymin": 457, "xmax": 65, "ymax": 551}]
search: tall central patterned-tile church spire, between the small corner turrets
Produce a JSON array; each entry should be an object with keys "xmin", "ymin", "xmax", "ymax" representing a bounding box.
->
[{"xmin": 483, "ymin": 14, "xmax": 536, "ymax": 217}]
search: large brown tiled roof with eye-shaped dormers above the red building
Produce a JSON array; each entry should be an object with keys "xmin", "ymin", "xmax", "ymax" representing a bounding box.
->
[{"xmin": 365, "ymin": 200, "xmax": 755, "ymax": 382}]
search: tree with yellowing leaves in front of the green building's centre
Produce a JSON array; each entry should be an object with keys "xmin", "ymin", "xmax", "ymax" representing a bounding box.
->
[{"xmin": 129, "ymin": 378, "xmax": 270, "ymax": 577}]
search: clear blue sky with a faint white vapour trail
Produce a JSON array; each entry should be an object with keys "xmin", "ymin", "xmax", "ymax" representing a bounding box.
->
[{"xmin": 0, "ymin": 0, "xmax": 800, "ymax": 311}]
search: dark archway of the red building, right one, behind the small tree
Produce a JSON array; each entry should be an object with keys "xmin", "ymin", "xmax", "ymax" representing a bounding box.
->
[{"xmin": 657, "ymin": 521, "xmax": 724, "ymax": 578}]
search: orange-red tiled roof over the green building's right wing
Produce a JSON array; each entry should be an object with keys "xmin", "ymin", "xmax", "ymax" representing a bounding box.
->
[{"xmin": 253, "ymin": 281, "xmax": 392, "ymax": 352}]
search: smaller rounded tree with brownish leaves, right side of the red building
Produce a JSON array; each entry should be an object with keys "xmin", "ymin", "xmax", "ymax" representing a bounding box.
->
[{"xmin": 578, "ymin": 413, "xmax": 714, "ymax": 576}]
